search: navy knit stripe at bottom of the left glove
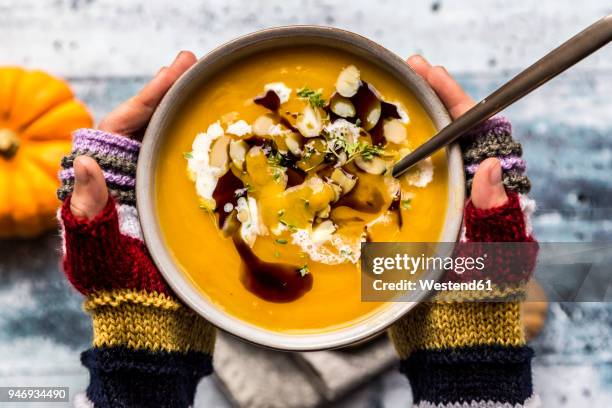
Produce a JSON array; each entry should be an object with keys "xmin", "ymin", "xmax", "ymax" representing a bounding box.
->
[{"xmin": 81, "ymin": 347, "xmax": 212, "ymax": 408}]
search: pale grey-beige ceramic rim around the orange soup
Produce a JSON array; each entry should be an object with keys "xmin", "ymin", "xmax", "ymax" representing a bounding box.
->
[{"xmin": 136, "ymin": 25, "xmax": 465, "ymax": 351}]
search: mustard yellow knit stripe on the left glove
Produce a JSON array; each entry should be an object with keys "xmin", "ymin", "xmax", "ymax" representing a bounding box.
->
[{"xmin": 85, "ymin": 290, "xmax": 215, "ymax": 354}]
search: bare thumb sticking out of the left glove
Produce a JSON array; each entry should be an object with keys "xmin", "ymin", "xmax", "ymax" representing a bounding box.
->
[{"xmin": 70, "ymin": 156, "xmax": 108, "ymax": 220}]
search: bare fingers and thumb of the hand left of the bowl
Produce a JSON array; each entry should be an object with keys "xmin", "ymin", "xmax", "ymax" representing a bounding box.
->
[{"xmin": 70, "ymin": 51, "xmax": 196, "ymax": 220}]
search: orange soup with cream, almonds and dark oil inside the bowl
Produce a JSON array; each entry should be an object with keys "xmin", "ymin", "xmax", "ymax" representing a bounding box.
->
[{"xmin": 155, "ymin": 47, "xmax": 448, "ymax": 333}]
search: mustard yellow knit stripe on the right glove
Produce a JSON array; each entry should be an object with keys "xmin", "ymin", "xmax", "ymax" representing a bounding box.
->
[{"xmin": 389, "ymin": 302, "xmax": 525, "ymax": 358}]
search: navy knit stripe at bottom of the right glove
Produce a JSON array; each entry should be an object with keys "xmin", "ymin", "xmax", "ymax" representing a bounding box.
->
[{"xmin": 400, "ymin": 345, "xmax": 533, "ymax": 405}]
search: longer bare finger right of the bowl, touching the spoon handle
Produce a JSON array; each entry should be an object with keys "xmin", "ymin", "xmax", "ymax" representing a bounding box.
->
[{"xmin": 426, "ymin": 66, "xmax": 475, "ymax": 119}]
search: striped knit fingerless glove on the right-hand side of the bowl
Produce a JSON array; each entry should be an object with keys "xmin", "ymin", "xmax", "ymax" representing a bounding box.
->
[{"xmin": 390, "ymin": 118, "xmax": 536, "ymax": 408}]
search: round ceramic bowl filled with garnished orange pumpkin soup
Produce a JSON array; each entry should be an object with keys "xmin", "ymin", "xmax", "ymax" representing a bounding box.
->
[{"xmin": 137, "ymin": 26, "xmax": 464, "ymax": 351}]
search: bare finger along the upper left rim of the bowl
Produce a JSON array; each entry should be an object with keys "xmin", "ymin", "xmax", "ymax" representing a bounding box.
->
[{"xmin": 98, "ymin": 51, "xmax": 197, "ymax": 136}]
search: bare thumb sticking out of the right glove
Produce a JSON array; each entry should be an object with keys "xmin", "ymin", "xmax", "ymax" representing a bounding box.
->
[{"xmin": 471, "ymin": 157, "xmax": 508, "ymax": 210}]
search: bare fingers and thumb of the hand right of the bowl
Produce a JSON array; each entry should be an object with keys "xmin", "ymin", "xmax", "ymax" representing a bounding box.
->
[{"xmin": 408, "ymin": 55, "xmax": 508, "ymax": 210}]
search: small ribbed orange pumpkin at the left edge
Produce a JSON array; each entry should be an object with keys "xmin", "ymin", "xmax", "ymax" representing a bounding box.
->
[{"xmin": 0, "ymin": 67, "xmax": 93, "ymax": 238}]
